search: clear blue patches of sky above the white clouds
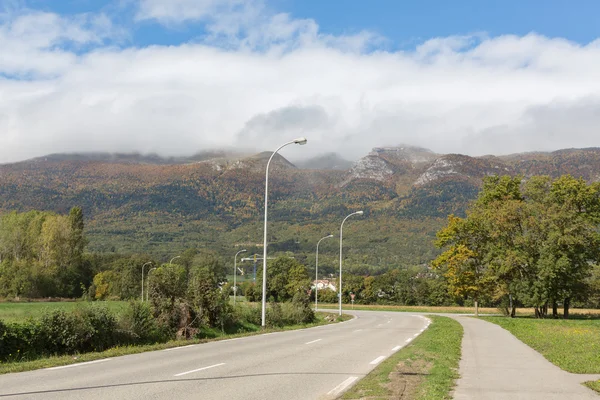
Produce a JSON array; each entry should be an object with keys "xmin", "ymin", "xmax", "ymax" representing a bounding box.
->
[{"xmin": 19, "ymin": 0, "xmax": 600, "ymax": 50}]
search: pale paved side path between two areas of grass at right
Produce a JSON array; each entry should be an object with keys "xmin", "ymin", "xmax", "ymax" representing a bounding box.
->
[{"xmin": 454, "ymin": 317, "xmax": 600, "ymax": 400}]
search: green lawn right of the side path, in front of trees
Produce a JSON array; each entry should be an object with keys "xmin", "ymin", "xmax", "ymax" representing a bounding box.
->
[{"xmin": 483, "ymin": 317, "xmax": 600, "ymax": 374}]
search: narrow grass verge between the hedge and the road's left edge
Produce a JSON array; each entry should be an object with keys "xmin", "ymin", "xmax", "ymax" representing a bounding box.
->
[{"xmin": 0, "ymin": 312, "xmax": 352, "ymax": 374}]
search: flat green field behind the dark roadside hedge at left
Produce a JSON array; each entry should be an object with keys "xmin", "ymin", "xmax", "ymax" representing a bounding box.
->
[{"xmin": 0, "ymin": 301, "xmax": 127, "ymax": 322}]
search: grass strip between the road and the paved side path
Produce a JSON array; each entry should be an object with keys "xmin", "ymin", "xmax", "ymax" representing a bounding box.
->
[{"xmin": 342, "ymin": 316, "xmax": 463, "ymax": 400}]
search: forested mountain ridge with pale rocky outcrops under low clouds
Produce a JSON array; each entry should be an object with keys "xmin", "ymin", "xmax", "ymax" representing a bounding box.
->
[{"xmin": 0, "ymin": 146, "xmax": 600, "ymax": 273}]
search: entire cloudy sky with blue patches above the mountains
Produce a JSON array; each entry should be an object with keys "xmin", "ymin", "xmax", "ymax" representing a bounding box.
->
[{"xmin": 0, "ymin": 0, "xmax": 600, "ymax": 163}]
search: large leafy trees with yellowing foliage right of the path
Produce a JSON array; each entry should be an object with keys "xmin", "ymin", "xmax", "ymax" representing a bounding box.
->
[{"xmin": 433, "ymin": 175, "xmax": 600, "ymax": 318}]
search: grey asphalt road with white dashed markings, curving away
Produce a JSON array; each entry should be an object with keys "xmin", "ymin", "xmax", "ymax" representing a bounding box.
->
[{"xmin": 0, "ymin": 311, "xmax": 428, "ymax": 400}]
